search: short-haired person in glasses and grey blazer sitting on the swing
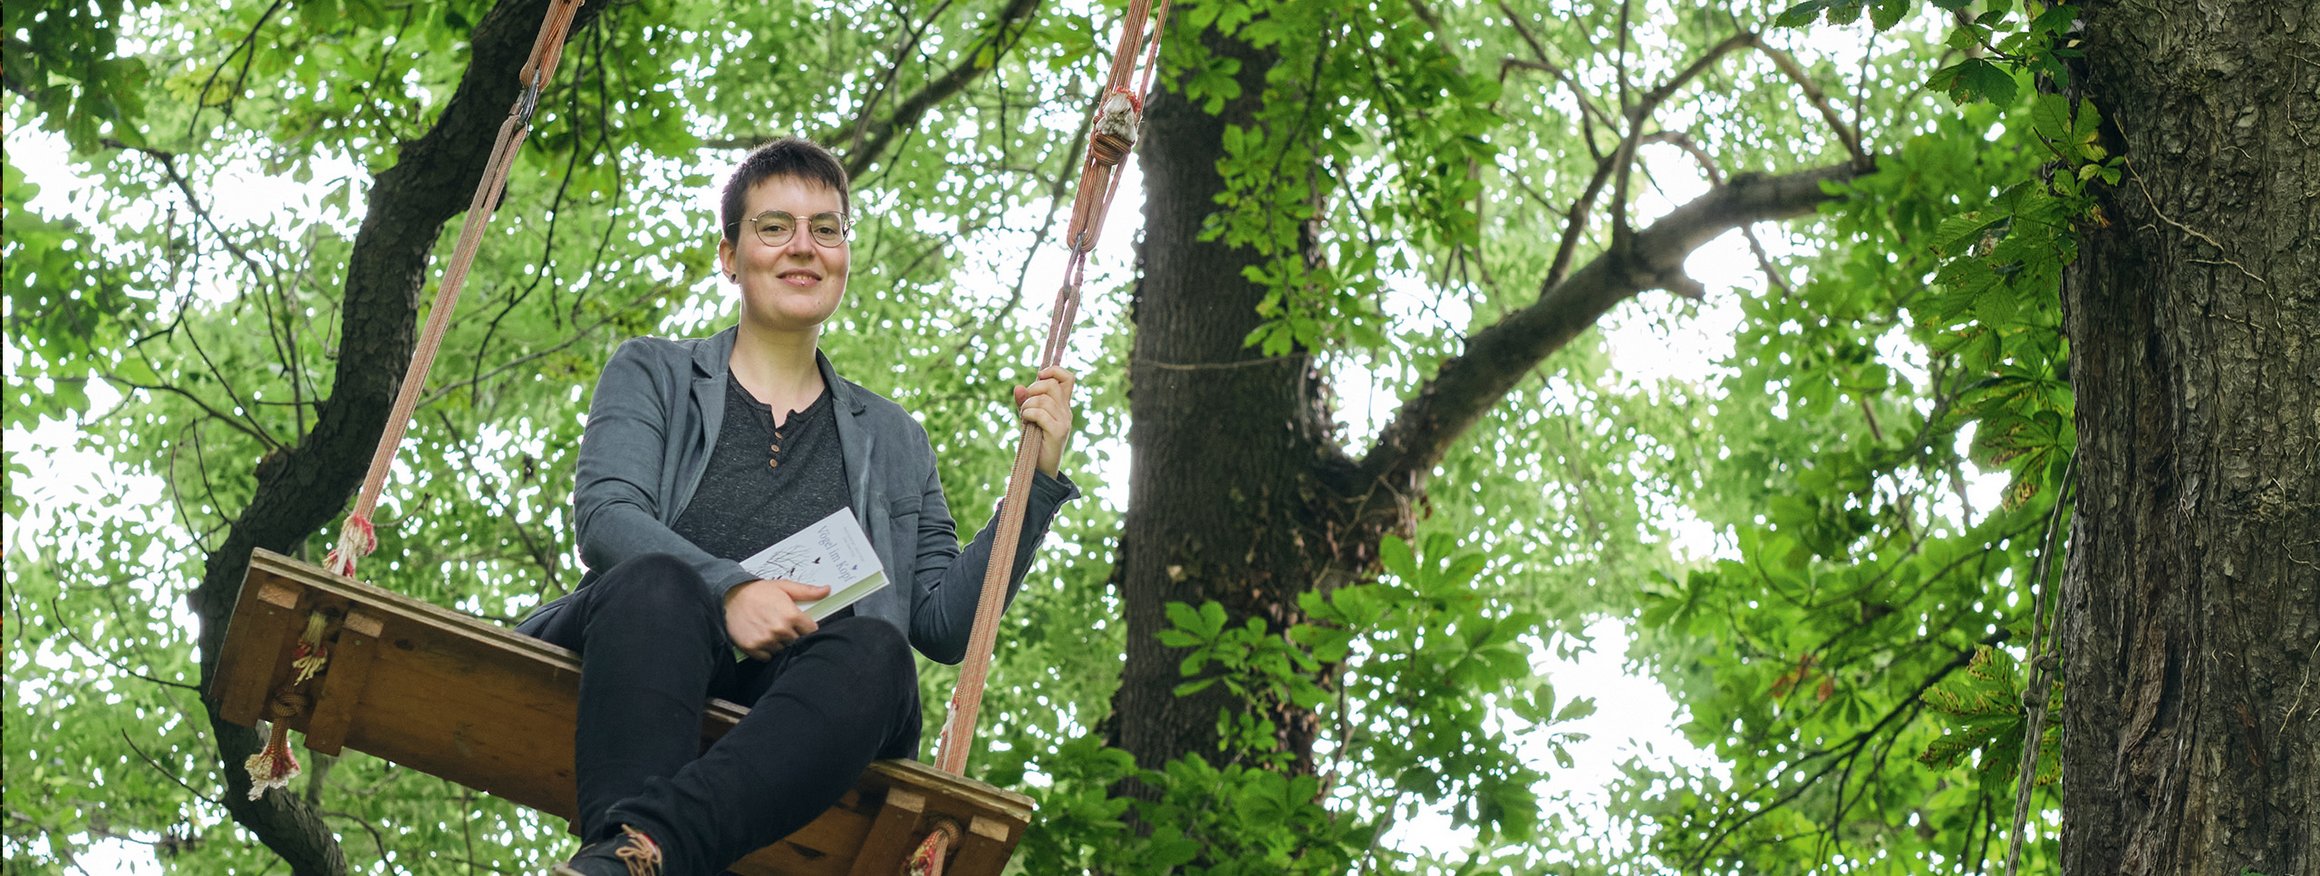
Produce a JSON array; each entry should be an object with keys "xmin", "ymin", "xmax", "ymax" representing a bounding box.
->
[{"xmin": 520, "ymin": 139, "xmax": 1079, "ymax": 876}]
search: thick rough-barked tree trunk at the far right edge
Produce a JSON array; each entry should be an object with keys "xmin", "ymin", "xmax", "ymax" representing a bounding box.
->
[{"xmin": 2062, "ymin": 0, "xmax": 2320, "ymax": 876}]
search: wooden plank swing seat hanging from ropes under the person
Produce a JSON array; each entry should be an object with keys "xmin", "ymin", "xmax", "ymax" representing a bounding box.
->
[{"xmin": 211, "ymin": 549, "xmax": 1032, "ymax": 876}]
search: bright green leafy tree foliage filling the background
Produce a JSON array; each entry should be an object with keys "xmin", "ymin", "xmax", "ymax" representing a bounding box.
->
[{"xmin": 0, "ymin": 0, "xmax": 2074, "ymax": 874}]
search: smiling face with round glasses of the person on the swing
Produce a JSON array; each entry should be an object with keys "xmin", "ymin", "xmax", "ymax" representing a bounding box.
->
[{"xmin": 717, "ymin": 176, "xmax": 851, "ymax": 331}]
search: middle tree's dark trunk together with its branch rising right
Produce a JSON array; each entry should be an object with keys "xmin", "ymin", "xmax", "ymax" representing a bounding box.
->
[{"xmin": 1109, "ymin": 32, "xmax": 1868, "ymax": 769}]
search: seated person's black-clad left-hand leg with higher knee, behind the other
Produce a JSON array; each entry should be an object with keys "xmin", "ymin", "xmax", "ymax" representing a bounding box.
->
[{"xmin": 522, "ymin": 554, "xmax": 733, "ymax": 841}]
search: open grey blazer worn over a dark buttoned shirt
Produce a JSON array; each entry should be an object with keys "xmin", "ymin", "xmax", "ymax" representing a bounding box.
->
[{"xmin": 517, "ymin": 329, "xmax": 1079, "ymax": 663}]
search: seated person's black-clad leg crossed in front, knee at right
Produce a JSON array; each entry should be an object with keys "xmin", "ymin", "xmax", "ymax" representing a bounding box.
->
[{"xmin": 608, "ymin": 619, "xmax": 919, "ymax": 874}]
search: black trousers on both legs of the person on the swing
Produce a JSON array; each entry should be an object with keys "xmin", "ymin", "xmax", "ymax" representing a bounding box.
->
[{"xmin": 517, "ymin": 554, "xmax": 919, "ymax": 876}]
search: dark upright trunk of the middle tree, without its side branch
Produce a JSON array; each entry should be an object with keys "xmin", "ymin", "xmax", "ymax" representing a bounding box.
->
[{"xmin": 1111, "ymin": 30, "xmax": 1353, "ymax": 767}]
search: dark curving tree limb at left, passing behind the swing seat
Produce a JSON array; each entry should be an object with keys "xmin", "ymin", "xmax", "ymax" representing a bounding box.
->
[{"xmin": 193, "ymin": 0, "xmax": 603, "ymax": 874}]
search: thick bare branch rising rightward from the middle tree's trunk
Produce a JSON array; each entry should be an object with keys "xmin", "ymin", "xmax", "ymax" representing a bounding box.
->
[{"xmin": 1362, "ymin": 165, "xmax": 1856, "ymax": 489}]
